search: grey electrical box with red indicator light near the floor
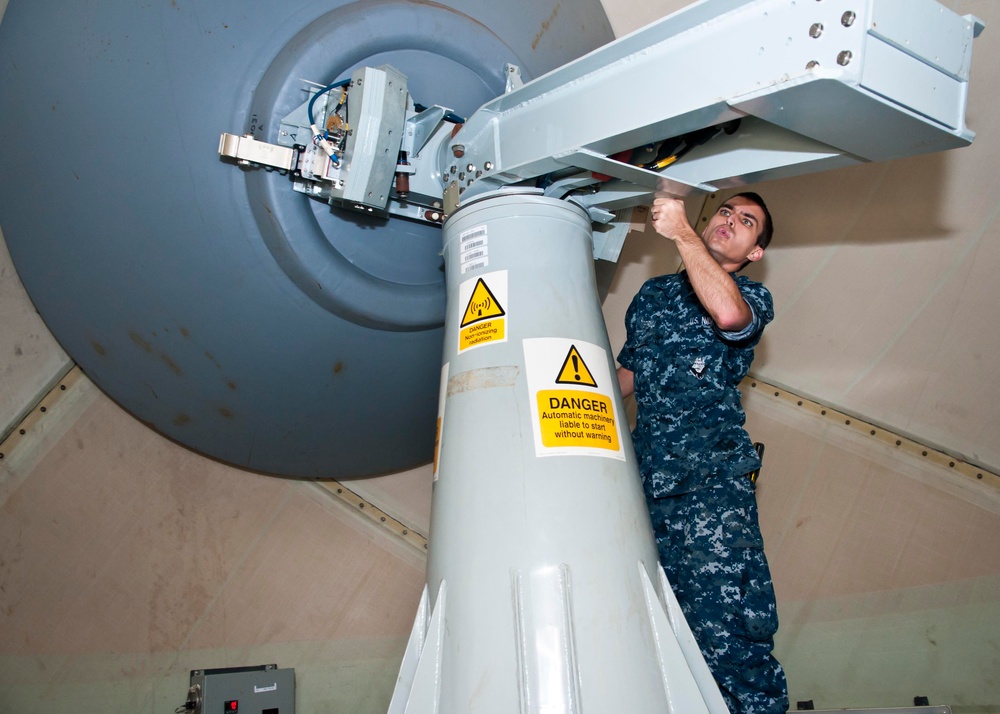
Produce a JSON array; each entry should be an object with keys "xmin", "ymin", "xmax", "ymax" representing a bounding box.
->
[{"xmin": 184, "ymin": 664, "xmax": 295, "ymax": 714}]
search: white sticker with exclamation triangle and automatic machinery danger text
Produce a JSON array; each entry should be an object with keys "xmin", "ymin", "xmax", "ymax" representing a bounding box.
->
[{"xmin": 524, "ymin": 338, "xmax": 625, "ymax": 460}]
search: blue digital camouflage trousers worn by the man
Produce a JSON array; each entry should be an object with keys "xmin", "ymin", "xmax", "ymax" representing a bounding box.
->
[{"xmin": 647, "ymin": 476, "xmax": 788, "ymax": 714}]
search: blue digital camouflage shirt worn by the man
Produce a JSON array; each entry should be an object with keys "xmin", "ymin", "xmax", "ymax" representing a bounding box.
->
[{"xmin": 618, "ymin": 272, "xmax": 774, "ymax": 498}]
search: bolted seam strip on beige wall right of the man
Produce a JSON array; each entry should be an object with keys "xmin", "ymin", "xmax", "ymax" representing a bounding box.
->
[{"xmin": 740, "ymin": 376, "xmax": 1000, "ymax": 489}]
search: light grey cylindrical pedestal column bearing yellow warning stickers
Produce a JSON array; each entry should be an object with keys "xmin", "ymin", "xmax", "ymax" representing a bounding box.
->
[{"xmin": 427, "ymin": 194, "xmax": 667, "ymax": 713}]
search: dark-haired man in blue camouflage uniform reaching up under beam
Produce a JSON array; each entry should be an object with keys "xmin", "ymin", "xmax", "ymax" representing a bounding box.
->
[{"xmin": 618, "ymin": 193, "xmax": 788, "ymax": 714}]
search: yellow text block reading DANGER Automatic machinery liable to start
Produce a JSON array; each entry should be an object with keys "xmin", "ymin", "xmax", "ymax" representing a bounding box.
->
[{"xmin": 538, "ymin": 389, "xmax": 619, "ymax": 451}]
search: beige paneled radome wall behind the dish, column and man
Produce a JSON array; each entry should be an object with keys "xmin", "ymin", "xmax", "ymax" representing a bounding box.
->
[{"xmin": 0, "ymin": 0, "xmax": 1000, "ymax": 714}]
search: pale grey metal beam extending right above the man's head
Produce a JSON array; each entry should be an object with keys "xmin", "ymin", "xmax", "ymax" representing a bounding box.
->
[{"xmin": 452, "ymin": 0, "xmax": 983, "ymax": 205}]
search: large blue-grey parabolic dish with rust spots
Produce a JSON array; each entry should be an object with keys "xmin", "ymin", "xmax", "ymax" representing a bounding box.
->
[{"xmin": 0, "ymin": 0, "xmax": 612, "ymax": 478}]
